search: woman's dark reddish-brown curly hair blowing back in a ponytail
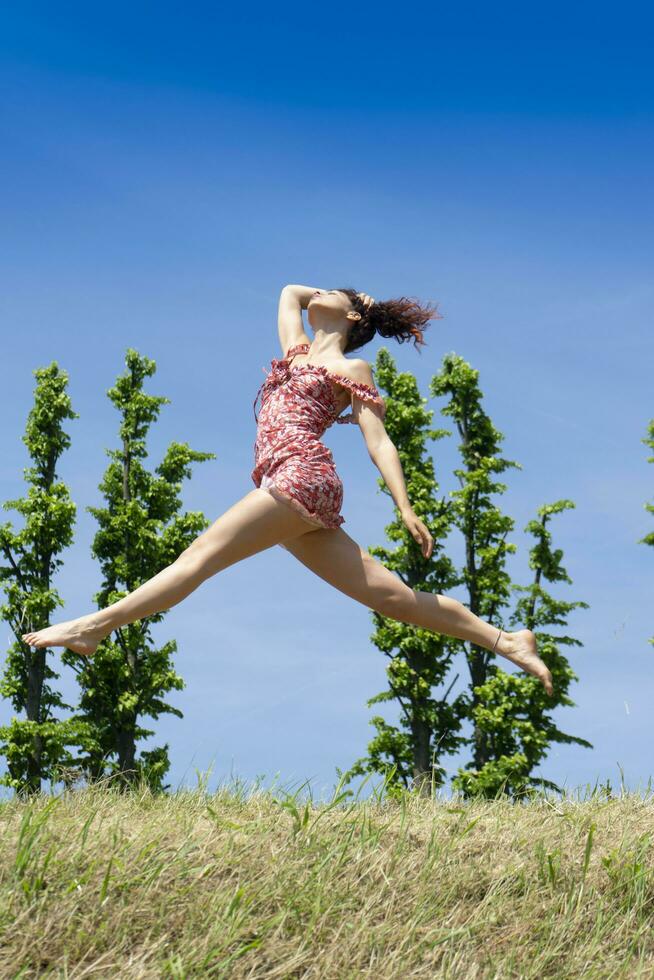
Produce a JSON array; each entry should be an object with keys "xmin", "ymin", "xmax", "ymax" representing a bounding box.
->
[{"xmin": 339, "ymin": 286, "xmax": 443, "ymax": 354}]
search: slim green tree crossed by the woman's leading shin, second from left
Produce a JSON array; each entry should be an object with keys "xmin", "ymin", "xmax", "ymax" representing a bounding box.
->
[{"xmin": 72, "ymin": 348, "xmax": 215, "ymax": 791}]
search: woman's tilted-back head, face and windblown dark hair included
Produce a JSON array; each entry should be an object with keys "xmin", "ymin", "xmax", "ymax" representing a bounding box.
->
[{"xmin": 307, "ymin": 286, "xmax": 442, "ymax": 354}]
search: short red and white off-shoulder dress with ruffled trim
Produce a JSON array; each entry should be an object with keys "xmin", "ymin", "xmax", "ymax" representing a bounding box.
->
[{"xmin": 251, "ymin": 344, "xmax": 386, "ymax": 528}]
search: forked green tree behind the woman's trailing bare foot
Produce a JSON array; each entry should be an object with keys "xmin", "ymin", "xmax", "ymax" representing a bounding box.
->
[{"xmin": 431, "ymin": 354, "xmax": 592, "ymax": 797}]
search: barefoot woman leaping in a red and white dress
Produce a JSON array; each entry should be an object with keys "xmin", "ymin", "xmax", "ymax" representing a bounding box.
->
[{"xmin": 23, "ymin": 285, "xmax": 553, "ymax": 695}]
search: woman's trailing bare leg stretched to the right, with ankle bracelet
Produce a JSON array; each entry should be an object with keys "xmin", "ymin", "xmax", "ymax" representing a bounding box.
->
[{"xmin": 285, "ymin": 528, "xmax": 552, "ymax": 695}]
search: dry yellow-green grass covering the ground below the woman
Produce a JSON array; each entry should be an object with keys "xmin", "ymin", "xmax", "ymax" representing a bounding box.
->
[{"xmin": 0, "ymin": 784, "xmax": 654, "ymax": 980}]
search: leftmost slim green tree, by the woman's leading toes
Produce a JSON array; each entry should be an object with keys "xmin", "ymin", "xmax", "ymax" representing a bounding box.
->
[{"xmin": 0, "ymin": 361, "xmax": 80, "ymax": 795}]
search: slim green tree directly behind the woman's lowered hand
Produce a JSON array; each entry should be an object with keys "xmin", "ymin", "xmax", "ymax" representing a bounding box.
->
[{"xmin": 339, "ymin": 348, "xmax": 467, "ymax": 796}]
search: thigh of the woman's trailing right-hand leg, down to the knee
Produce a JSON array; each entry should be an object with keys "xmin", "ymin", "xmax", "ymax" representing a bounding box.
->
[{"xmin": 284, "ymin": 528, "xmax": 415, "ymax": 616}]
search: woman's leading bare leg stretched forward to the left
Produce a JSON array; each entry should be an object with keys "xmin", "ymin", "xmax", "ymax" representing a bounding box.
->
[{"xmin": 23, "ymin": 488, "xmax": 316, "ymax": 656}]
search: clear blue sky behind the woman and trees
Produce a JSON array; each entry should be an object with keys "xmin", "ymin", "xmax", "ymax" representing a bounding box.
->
[{"xmin": 0, "ymin": 3, "xmax": 654, "ymax": 796}]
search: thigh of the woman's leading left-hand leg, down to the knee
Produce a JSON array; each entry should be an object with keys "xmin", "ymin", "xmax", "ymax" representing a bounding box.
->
[{"xmin": 184, "ymin": 487, "xmax": 316, "ymax": 575}]
